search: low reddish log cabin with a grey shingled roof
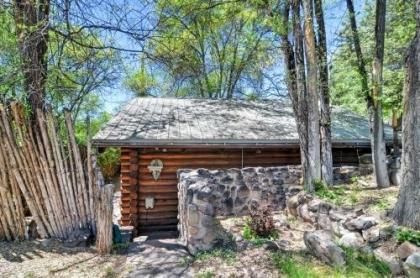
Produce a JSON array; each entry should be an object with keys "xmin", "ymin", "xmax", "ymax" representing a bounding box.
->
[{"xmin": 92, "ymin": 97, "xmax": 392, "ymax": 233}]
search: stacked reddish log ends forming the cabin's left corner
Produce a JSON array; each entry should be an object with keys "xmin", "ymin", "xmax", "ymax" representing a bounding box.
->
[{"xmin": 120, "ymin": 148, "xmax": 138, "ymax": 227}]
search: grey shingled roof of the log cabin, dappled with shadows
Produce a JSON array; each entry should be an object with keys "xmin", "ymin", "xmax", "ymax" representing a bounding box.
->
[{"xmin": 93, "ymin": 97, "xmax": 392, "ymax": 146}]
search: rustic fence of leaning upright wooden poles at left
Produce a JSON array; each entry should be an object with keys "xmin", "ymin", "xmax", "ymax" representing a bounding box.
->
[{"xmin": 0, "ymin": 103, "xmax": 103, "ymax": 240}]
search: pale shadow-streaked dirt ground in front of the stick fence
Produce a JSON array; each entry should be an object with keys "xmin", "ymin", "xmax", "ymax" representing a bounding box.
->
[{"xmin": 0, "ymin": 241, "xmax": 125, "ymax": 277}]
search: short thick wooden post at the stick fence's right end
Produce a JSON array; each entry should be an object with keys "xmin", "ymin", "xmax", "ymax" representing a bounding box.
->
[{"xmin": 96, "ymin": 184, "xmax": 114, "ymax": 254}]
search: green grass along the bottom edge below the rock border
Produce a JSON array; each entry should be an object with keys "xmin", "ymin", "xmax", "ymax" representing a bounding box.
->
[{"xmin": 273, "ymin": 249, "xmax": 391, "ymax": 278}]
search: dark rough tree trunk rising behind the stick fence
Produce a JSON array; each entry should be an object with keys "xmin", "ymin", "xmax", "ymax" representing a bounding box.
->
[{"xmin": 13, "ymin": 0, "xmax": 50, "ymax": 114}]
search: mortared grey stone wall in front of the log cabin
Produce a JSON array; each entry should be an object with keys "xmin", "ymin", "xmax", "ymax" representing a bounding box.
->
[{"xmin": 178, "ymin": 166, "xmax": 301, "ymax": 254}]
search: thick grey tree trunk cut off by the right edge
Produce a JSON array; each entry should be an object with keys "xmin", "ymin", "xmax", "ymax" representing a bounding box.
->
[{"xmin": 394, "ymin": 0, "xmax": 420, "ymax": 230}]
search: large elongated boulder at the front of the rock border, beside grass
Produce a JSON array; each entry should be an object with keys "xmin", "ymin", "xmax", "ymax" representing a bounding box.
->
[{"xmin": 303, "ymin": 230, "xmax": 346, "ymax": 266}]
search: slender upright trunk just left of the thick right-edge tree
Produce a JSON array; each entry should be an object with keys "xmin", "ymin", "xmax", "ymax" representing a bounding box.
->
[{"xmin": 369, "ymin": 0, "xmax": 390, "ymax": 187}]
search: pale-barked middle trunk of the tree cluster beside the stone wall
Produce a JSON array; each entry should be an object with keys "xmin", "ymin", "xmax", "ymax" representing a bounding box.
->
[{"xmin": 304, "ymin": 0, "xmax": 321, "ymax": 192}]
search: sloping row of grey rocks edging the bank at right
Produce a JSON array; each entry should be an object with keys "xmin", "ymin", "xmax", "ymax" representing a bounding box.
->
[{"xmin": 286, "ymin": 191, "xmax": 420, "ymax": 277}]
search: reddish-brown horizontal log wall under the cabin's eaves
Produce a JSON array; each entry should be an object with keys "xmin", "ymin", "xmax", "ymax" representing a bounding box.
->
[{"xmin": 121, "ymin": 148, "xmax": 368, "ymax": 233}]
